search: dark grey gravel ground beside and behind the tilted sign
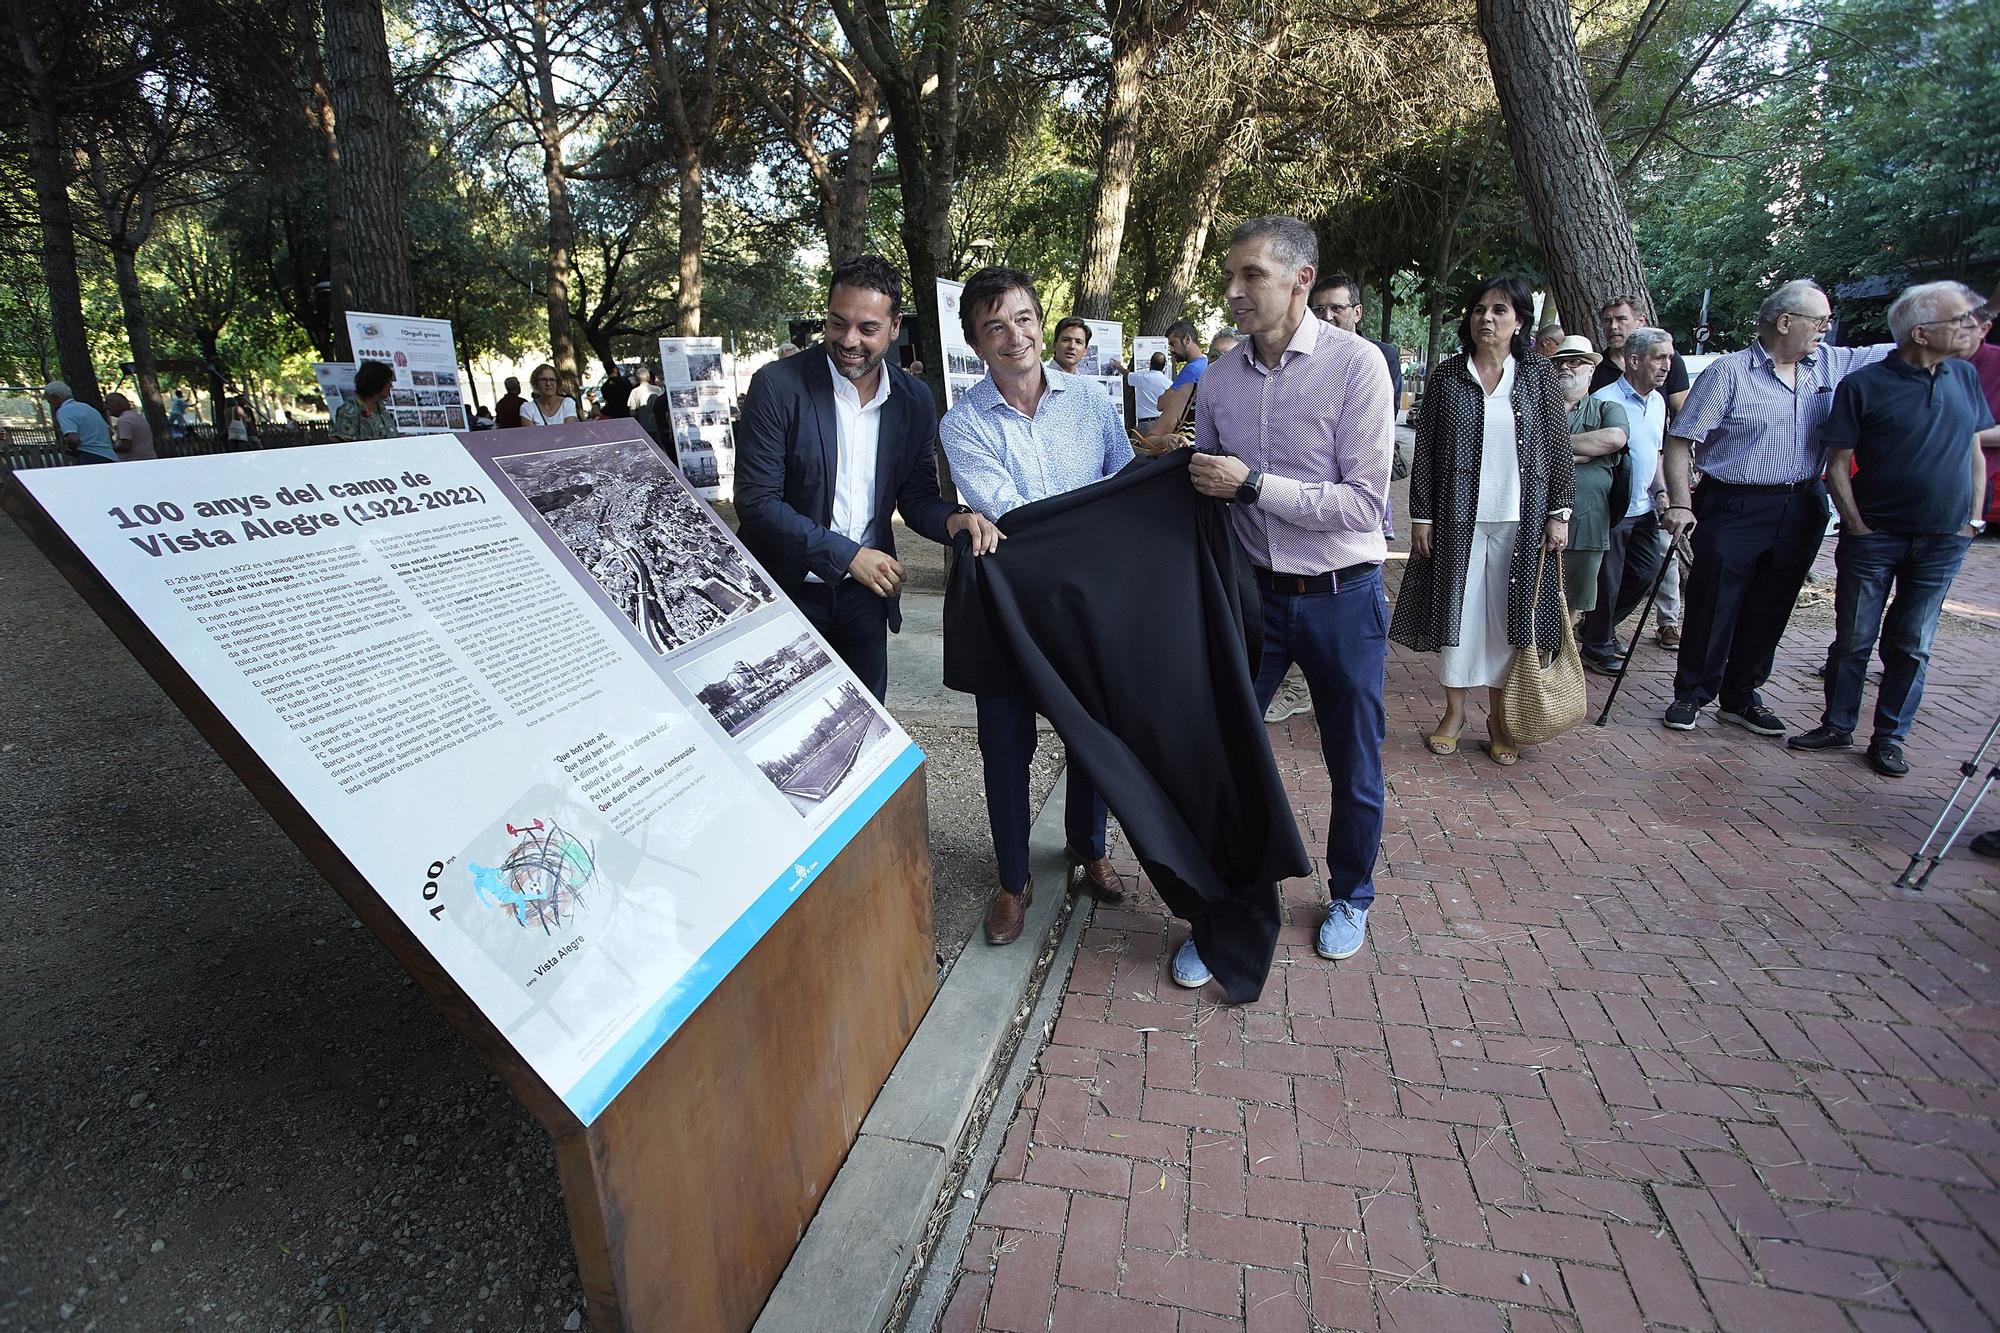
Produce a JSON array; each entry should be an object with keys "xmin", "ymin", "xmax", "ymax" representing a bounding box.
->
[{"xmin": 0, "ymin": 496, "xmax": 1060, "ymax": 1333}]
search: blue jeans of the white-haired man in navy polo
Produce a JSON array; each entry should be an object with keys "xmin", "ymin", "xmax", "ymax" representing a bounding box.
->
[{"xmin": 1820, "ymin": 532, "xmax": 1972, "ymax": 745}]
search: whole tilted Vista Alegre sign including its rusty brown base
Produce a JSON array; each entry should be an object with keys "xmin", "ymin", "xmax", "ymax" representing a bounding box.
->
[{"xmin": 4, "ymin": 420, "xmax": 936, "ymax": 1329}]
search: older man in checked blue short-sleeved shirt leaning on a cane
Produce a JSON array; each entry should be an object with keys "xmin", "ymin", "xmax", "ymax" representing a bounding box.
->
[{"xmin": 1662, "ymin": 278, "xmax": 1892, "ymax": 737}]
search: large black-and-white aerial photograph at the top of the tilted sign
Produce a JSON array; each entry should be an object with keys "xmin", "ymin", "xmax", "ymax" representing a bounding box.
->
[{"xmin": 494, "ymin": 430, "xmax": 776, "ymax": 654}]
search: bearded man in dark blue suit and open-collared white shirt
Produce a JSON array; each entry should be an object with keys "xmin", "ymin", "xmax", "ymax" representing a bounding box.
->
[{"xmin": 736, "ymin": 254, "xmax": 1000, "ymax": 699}]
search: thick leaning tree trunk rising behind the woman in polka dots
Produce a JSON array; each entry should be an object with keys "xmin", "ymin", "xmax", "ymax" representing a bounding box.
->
[{"xmin": 1478, "ymin": 0, "xmax": 1652, "ymax": 322}]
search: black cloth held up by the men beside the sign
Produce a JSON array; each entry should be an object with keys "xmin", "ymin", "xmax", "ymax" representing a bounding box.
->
[{"xmin": 944, "ymin": 450, "xmax": 1312, "ymax": 1003}]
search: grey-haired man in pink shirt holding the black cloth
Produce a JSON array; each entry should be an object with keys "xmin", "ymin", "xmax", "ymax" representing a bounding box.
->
[{"xmin": 1174, "ymin": 216, "xmax": 1396, "ymax": 987}]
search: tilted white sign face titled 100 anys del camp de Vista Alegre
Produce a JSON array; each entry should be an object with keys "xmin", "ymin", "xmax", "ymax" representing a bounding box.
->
[{"xmin": 16, "ymin": 422, "xmax": 922, "ymax": 1123}]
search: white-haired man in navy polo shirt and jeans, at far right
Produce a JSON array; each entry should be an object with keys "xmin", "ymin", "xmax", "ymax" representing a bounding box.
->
[{"xmin": 1786, "ymin": 282, "xmax": 2000, "ymax": 777}]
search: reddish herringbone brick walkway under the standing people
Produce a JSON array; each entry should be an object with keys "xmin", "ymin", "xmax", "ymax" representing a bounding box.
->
[{"xmin": 944, "ymin": 542, "xmax": 2000, "ymax": 1333}]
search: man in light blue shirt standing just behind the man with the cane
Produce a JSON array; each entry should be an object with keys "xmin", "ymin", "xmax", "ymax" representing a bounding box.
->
[{"xmin": 1578, "ymin": 328, "xmax": 1674, "ymax": 677}]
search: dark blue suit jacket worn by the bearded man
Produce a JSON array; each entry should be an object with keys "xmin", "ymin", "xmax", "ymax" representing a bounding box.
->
[{"xmin": 736, "ymin": 344, "xmax": 952, "ymax": 630}]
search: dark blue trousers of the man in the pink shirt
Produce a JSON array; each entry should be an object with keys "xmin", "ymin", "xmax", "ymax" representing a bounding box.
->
[{"xmin": 1256, "ymin": 568, "xmax": 1388, "ymax": 911}]
